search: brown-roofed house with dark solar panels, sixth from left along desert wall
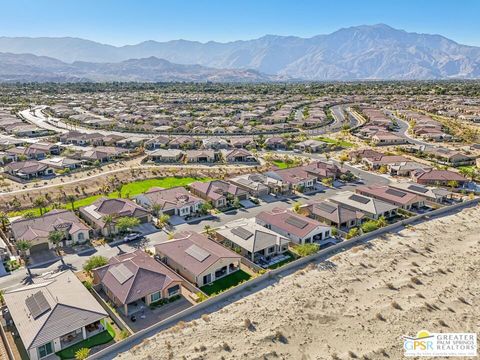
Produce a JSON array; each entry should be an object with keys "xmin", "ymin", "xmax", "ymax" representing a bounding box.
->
[{"xmin": 300, "ymin": 200, "xmax": 365, "ymax": 230}]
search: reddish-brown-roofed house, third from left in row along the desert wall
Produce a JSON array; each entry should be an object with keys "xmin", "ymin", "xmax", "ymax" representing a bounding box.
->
[{"xmin": 155, "ymin": 231, "xmax": 241, "ymax": 287}]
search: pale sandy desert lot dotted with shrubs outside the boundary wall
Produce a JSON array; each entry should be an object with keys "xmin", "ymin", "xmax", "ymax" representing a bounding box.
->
[{"xmin": 118, "ymin": 207, "xmax": 480, "ymax": 360}]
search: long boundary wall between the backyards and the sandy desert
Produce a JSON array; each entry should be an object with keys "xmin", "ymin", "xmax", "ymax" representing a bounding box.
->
[{"xmin": 89, "ymin": 198, "xmax": 480, "ymax": 359}]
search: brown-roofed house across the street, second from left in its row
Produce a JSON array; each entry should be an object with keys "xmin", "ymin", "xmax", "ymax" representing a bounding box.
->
[{"xmin": 78, "ymin": 198, "xmax": 152, "ymax": 236}]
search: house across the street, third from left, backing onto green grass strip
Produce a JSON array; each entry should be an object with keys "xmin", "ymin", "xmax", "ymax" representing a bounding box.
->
[{"xmin": 135, "ymin": 186, "xmax": 205, "ymax": 217}]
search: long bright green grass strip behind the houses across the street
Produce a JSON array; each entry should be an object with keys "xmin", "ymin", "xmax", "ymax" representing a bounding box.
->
[{"xmin": 8, "ymin": 177, "xmax": 213, "ymax": 217}]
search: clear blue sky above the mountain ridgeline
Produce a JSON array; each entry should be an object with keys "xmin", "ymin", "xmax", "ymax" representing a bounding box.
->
[{"xmin": 0, "ymin": 0, "xmax": 480, "ymax": 46}]
